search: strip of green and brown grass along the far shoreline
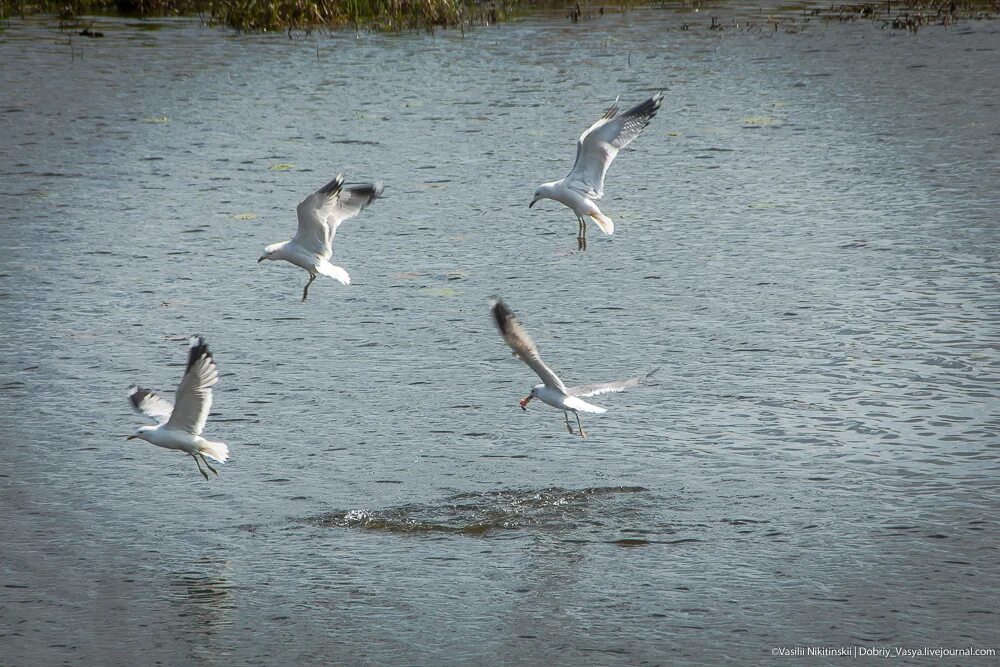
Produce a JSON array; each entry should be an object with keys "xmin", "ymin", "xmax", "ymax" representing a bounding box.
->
[{"xmin": 0, "ymin": 0, "xmax": 1000, "ymax": 37}]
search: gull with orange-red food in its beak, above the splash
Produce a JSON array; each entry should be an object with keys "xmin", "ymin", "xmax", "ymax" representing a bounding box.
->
[{"xmin": 493, "ymin": 300, "xmax": 656, "ymax": 438}]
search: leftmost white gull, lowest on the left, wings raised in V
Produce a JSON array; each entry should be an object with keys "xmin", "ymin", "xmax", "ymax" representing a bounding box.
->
[{"xmin": 126, "ymin": 336, "xmax": 229, "ymax": 479}]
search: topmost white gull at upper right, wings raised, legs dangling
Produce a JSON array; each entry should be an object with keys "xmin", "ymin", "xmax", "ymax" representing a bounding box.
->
[{"xmin": 528, "ymin": 93, "xmax": 663, "ymax": 250}]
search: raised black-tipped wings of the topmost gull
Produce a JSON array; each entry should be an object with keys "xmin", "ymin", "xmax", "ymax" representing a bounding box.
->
[{"xmin": 565, "ymin": 93, "xmax": 663, "ymax": 199}]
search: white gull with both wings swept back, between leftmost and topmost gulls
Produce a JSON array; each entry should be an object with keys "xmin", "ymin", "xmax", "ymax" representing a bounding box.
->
[{"xmin": 257, "ymin": 174, "xmax": 382, "ymax": 301}]
